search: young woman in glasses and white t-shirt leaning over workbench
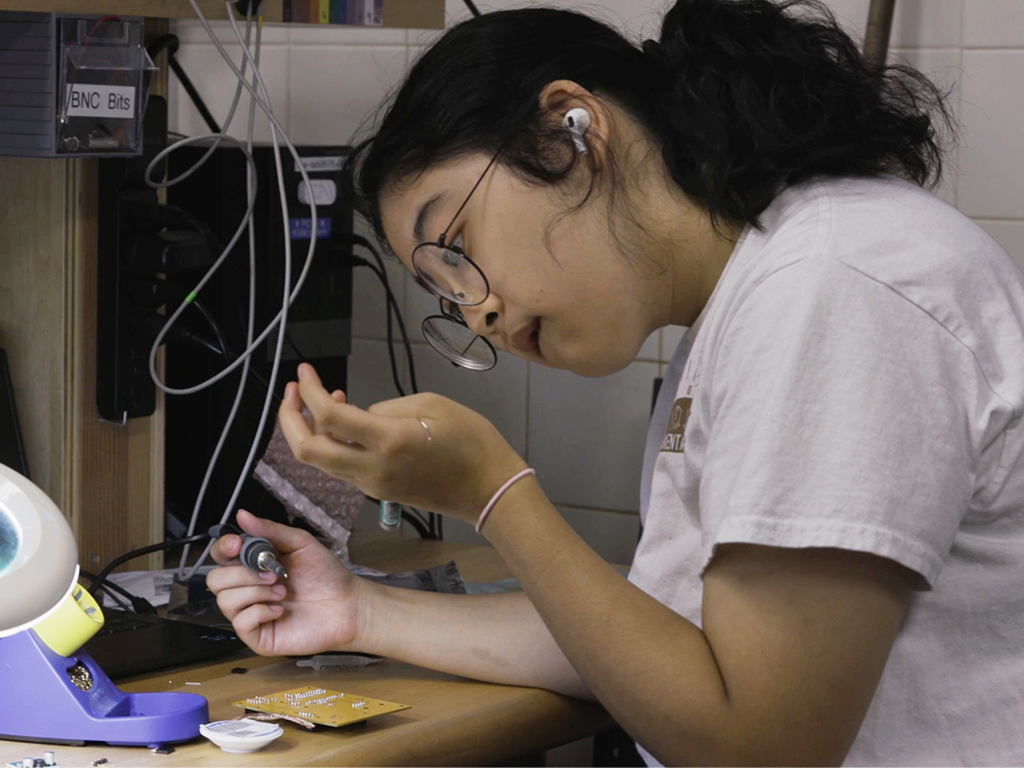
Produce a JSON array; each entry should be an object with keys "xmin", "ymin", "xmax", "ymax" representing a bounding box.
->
[{"xmin": 208, "ymin": 0, "xmax": 1024, "ymax": 765}]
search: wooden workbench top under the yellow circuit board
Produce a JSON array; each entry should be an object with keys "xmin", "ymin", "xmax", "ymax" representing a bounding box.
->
[{"xmin": 0, "ymin": 532, "xmax": 612, "ymax": 768}]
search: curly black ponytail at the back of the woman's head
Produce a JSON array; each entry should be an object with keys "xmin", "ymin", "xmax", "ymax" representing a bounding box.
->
[{"xmin": 643, "ymin": 0, "xmax": 952, "ymax": 224}]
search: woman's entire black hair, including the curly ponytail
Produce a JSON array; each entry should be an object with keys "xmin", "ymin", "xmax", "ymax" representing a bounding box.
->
[{"xmin": 347, "ymin": 0, "xmax": 954, "ymax": 249}]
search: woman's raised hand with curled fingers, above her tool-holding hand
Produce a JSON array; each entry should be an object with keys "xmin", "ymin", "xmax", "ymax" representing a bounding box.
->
[{"xmin": 278, "ymin": 364, "xmax": 526, "ymax": 522}]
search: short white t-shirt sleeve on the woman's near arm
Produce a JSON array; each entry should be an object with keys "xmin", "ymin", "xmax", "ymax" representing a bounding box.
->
[{"xmin": 700, "ymin": 258, "xmax": 988, "ymax": 588}]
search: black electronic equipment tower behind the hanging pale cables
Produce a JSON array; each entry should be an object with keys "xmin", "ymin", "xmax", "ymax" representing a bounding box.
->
[{"xmin": 159, "ymin": 144, "xmax": 352, "ymax": 527}]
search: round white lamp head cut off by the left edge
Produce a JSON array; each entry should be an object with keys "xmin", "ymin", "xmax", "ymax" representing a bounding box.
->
[{"xmin": 0, "ymin": 464, "xmax": 78, "ymax": 637}]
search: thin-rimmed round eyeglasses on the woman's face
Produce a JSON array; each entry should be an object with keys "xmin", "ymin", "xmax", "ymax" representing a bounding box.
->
[{"xmin": 413, "ymin": 148, "xmax": 501, "ymax": 371}]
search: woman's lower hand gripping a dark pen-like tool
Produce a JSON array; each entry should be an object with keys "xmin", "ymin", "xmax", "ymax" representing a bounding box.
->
[{"xmin": 206, "ymin": 510, "xmax": 366, "ymax": 656}]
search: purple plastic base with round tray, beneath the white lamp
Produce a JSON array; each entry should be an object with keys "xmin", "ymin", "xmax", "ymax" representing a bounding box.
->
[{"xmin": 0, "ymin": 630, "xmax": 210, "ymax": 748}]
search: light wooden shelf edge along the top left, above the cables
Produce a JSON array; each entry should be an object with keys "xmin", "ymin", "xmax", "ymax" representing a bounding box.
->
[{"xmin": 0, "ymin": 0, "xmax": 444, "ymax": 30}]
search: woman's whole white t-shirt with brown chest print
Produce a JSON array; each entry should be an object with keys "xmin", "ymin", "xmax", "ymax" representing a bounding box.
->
[{"xmin": 630, "ymin": 179, "xmax": 1024, "ymax": 766}]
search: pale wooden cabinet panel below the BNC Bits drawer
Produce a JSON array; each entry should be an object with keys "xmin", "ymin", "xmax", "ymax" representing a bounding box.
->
[{"xmin": 0, "ymin": 158, "xmax": 163, "ymax": 571}]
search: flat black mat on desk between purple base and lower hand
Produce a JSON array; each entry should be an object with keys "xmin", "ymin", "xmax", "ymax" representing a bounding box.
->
[{"xmin": 82, "ymin": 609, "xmax": 246, "ymax": 680}]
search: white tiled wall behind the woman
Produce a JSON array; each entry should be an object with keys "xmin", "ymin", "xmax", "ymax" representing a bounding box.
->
[{"xmin": 170, "ymin": 0, "xmax": 1024, "ymax": 562}]
